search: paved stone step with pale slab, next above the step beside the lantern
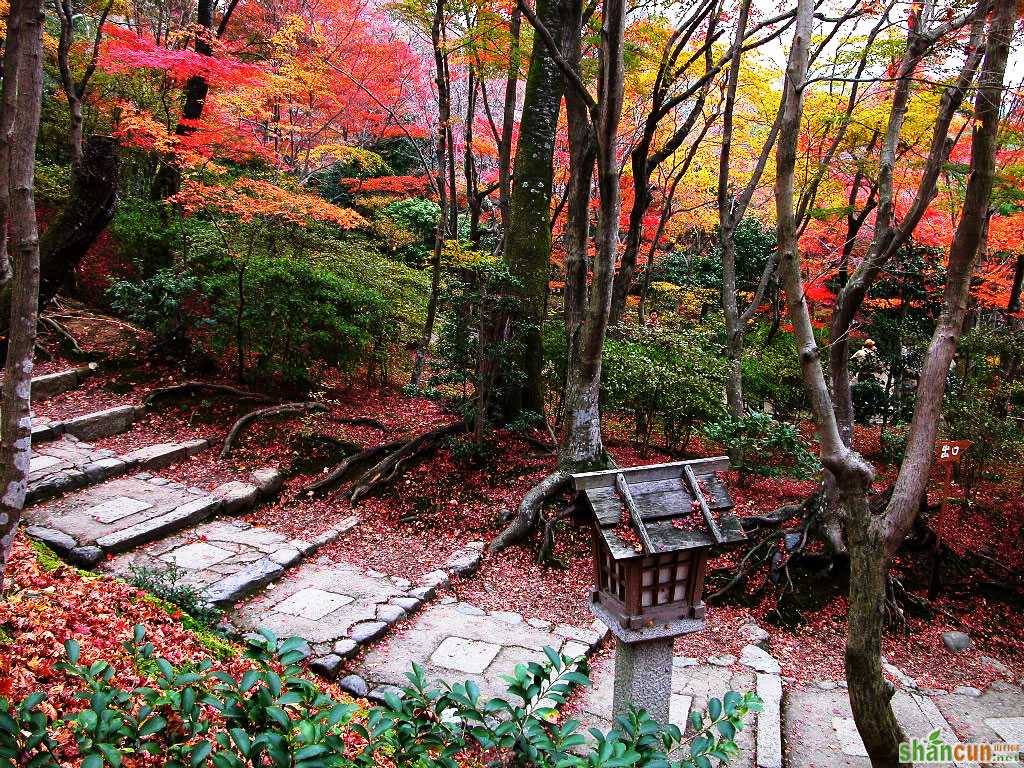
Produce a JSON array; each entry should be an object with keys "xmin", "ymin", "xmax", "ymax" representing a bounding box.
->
[{"xmin": 230, "ymin": 543, "xmax": 483, "ymax": 678}]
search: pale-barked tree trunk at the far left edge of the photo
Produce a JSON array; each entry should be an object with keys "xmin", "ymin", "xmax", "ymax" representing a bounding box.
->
[{"xmin": 0, "ymin": 0, "xmax": 43, "ymax": 588}]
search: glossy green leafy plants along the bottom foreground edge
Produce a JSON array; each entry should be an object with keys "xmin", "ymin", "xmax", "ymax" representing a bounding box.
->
[{"xmin": 0, "ymin": 626, "xmax": 761, "ymax": 768}]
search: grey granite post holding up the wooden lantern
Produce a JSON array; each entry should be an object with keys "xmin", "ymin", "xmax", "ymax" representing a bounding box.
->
[{"xmin": 611, "ymin": 637, "xmax": 673, "ymax": 725}]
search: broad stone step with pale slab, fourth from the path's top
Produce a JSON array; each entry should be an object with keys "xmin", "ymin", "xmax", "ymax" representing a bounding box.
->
[{"xmin": 25, "ymin": 472, "xmax": 280, "ymax": 567}]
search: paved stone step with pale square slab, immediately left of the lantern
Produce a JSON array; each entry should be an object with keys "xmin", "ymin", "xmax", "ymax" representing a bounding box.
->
[{"xmin": 352, "ymin": 598, "xmax": 607, "ymax": 698}]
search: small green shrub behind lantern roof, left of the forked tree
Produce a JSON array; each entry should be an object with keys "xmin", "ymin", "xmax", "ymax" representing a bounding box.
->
[{"xmin": 703, "ymin": 411, "xmax": 819, "ymax": 479}]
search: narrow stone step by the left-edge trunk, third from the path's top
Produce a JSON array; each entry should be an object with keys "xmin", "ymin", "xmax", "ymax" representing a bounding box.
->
[{"xmin": 27, "ymin": 435, "xmax": 211, "ymax": 504}]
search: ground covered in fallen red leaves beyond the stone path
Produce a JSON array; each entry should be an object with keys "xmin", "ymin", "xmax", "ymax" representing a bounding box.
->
[{"xmin": 8, "ymin": 313, "xmax": 1024, "ymax": 690}]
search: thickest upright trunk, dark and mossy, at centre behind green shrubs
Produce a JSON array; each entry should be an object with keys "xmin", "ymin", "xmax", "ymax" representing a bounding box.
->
[{"xmin": 503, "ymin": 0, "xmax": 563, "ymax": 418}]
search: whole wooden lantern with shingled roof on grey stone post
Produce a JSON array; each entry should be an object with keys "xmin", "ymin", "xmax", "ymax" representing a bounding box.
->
[{"xmin": 572, "ymin": 457, "xmax": 745, "ymax": 723}]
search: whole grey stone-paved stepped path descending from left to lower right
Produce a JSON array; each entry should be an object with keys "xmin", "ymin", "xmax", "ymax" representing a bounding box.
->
[{"xmin": 26, "ymin": 370, "xmax": 1024, "ymax": 768}]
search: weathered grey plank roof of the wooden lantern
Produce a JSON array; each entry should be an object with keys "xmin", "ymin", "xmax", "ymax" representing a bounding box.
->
[{"xmin": 572, "ymin": 456, "xmax": 745, "ymax": 560}]
